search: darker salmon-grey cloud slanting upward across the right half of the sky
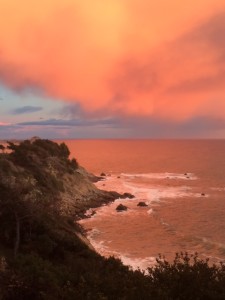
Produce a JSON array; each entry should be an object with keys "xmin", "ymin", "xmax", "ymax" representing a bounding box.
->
[{"xmin": 111, "ymin": 11, "xmax": 225, "ymax": 122}]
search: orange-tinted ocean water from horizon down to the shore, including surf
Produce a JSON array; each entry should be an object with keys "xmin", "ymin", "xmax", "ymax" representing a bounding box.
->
[{"xmin": 65, "ymin": 140, "xmax": 225, "ymax": 269}]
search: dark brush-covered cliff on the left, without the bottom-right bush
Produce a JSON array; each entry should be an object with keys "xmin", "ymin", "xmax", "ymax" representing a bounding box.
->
[{"xmin": 0, "ymin": 139, "xmax": 149, "ymax": 300}]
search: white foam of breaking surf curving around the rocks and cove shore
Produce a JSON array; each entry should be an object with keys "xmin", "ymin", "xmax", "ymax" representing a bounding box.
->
[{"xmin": 81, "ymin": 173, "xmax": 208, "ymax": 270}]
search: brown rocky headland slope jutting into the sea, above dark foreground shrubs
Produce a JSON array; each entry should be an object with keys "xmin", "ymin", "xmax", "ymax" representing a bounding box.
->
[{"xmin": 0, "ymin": 139, "xmax": 120, "ymax": 218}]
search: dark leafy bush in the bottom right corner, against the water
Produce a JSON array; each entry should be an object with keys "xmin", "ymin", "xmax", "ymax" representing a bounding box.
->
[{"xmin": 148, "ymin": 252, "xmax": 225, "ymax": 300}]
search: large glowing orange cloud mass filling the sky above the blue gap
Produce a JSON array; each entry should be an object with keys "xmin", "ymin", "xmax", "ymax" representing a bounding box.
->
[{"xmin": 0, "ymin": 0, "xmax": 225, "ymax": 121}]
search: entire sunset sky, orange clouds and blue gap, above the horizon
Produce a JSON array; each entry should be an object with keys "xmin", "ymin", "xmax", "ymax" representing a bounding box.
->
[{"xmin": 0, "ymin": 0, "xmax": 225, "ymax": 139}]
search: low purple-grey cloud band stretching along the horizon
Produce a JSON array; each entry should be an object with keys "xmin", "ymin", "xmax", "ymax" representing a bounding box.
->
[{"xmin": 0, "ymin": 116, "xmax": 225, "ymax": 139}]
